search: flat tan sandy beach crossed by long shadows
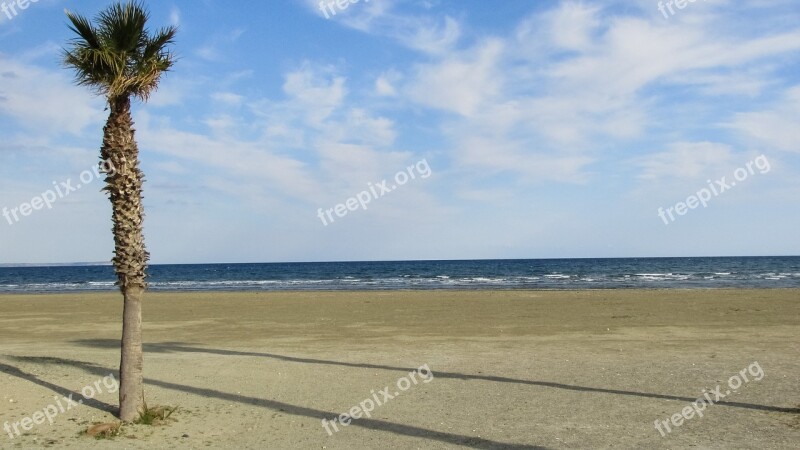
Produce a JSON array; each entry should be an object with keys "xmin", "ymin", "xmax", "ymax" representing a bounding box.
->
[{"xmin": 0, "ymin": 290, "xmax": 800, "ymax": 449}]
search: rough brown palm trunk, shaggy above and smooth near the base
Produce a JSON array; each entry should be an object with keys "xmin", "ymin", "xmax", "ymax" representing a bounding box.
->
[{"xmin": 100, "ymin": 96, "xmax": 149, "ymax": 422}]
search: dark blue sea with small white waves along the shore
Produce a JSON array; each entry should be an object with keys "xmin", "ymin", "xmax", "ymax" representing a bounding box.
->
[{"xmin": 0, "ymin": 256, "xmax": 800, "ymax": 293}]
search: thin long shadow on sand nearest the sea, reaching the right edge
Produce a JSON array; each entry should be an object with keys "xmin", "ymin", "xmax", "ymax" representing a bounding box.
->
[{"xmin": 73, "ymin": 339, "xmax": 800, "ymax": 414}]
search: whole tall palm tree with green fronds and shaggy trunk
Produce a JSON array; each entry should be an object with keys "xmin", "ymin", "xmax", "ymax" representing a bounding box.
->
[{"xmin": 63, "ymin": 1, "xmax": 177, "ymax": 422}]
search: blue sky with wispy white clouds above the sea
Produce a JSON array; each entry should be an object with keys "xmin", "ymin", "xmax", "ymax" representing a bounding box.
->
[{"xmin": 0, "ymin": 0, "xmax": 800, "ymax": 264}]
